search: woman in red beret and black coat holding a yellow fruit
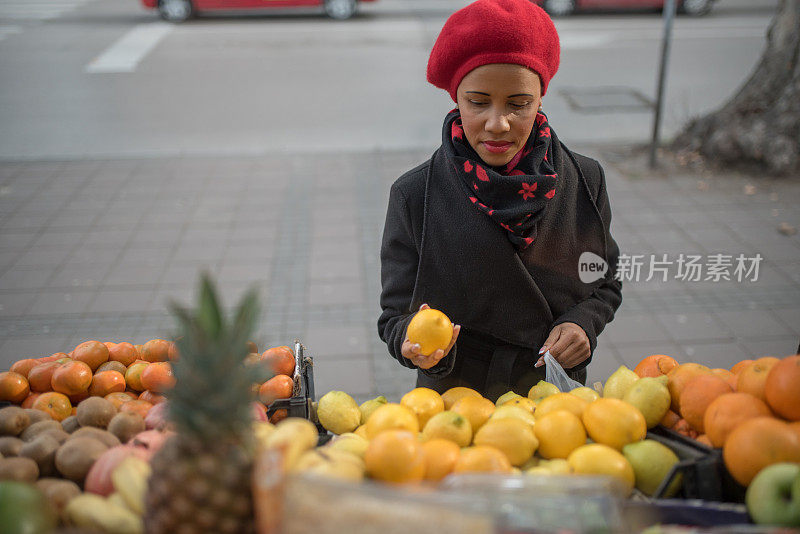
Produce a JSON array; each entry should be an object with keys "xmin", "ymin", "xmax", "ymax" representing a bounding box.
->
[{"xmin": 378, "ymin": 0, "xmax": 622, "ymax": 400}]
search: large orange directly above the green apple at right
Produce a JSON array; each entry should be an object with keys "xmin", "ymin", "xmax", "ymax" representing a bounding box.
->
[{"xmin": 722, "ymin": 417, "xmax": 800, "ymax": 486}]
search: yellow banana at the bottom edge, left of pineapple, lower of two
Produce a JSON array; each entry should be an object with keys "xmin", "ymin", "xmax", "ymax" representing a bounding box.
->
[{"xmin": 64, "ymin": 493, "xmax": 144, "ymax": 534}]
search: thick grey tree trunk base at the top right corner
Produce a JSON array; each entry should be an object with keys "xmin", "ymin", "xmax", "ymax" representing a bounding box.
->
[{"xmin": 671, "ymin": 0, "xmax": 800, "ymax": 175}]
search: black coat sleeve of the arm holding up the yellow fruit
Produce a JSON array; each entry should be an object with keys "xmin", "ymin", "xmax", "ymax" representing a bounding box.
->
[{"xmin": 378, "ymin": 184, "xmax": 456, "ymax": 377}]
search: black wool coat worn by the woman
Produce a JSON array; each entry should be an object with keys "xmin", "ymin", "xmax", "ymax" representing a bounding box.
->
[{"xmin": 378, "ymin": 136, "xmax": 622, "ymax": 400}]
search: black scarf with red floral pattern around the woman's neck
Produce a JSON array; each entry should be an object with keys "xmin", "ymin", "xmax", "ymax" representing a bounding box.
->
[{"xmin": 442, "ymin": 109, "xmax": 558, "ymax": 250}]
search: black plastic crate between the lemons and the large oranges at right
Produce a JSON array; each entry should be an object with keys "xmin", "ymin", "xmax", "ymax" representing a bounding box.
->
[{"xmin": 647, "ymin": 425, "xmax": 747, "ymax": 503}]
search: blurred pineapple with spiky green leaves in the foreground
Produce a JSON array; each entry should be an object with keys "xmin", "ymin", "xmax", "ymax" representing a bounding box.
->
[{"xmin": 144, "ymin": 276, "xmax": 260, "ymax": 534}]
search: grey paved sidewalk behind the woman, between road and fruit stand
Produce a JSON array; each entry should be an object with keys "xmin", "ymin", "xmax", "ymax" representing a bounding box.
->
[{"xmin": 0, "ymin": 147, "xmax": 800, "ymax": 401}]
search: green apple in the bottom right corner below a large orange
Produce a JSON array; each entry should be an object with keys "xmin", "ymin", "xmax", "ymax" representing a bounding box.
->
[{"xmin": 745, "ymin": 463, "xmax": 800, "ymax": 527}]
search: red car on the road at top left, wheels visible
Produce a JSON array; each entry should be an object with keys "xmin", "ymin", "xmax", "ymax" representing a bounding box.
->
[{"xmin": 141, "ymin": 0, "xmax": 375, "ymax": 22}]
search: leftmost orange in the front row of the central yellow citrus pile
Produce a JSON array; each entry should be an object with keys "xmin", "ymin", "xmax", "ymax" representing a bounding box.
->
[{"xmin": 364, "ymin": 432, "xmax": 426, "ymax": 484}]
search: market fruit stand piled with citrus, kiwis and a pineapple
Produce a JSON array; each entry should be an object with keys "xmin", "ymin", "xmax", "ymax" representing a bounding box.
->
[{"xmin": 0, "ymin": 282, "xmax": 800, "ymax": 534}]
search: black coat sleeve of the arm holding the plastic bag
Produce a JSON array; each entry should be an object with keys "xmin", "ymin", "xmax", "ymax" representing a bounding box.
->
[{"xmin": 553, "ymin": 164, "xmax": 622, "ymax": 369}]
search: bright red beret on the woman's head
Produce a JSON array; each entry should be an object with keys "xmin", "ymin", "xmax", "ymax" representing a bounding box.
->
[{"xmin": 428, "ymin": 0, "xmax": 561, "ymax": 101}]
